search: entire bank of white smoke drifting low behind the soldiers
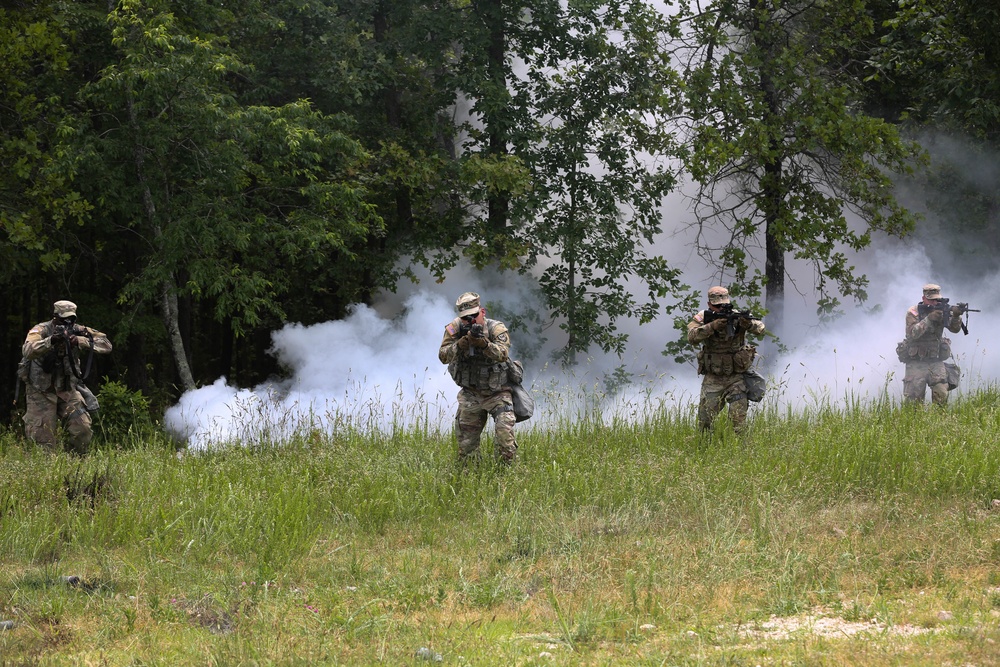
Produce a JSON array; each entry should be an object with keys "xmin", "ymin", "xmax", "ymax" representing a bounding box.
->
[{"xmin": 165, "ymin": 235, "xmax": 1000, "ymax": 448}]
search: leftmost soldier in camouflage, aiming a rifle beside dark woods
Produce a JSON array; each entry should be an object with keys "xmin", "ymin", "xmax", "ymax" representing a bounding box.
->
[{"xmin": 18, "ymin": 301, "xmax": 111, "ymax": 455}]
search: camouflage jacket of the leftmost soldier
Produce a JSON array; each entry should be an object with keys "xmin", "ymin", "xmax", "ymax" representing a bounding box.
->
[{"xmin": 18, "ymin": 320, "xmax": 111, "ymax": 391}]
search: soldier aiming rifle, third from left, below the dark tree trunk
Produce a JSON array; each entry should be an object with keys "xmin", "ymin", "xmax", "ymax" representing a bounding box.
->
[{"xmin": 688, "ymin": 287, "xmax": 764, "ymax": 432}]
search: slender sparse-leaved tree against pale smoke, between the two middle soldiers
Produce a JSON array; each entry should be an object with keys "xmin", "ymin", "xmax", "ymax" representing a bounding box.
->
[{"xmin": 512, "ymin": 2, "xmax": 682, "ymax": 363}]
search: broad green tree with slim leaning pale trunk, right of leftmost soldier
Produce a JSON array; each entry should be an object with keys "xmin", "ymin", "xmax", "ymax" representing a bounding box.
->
[{"xmin": 65, "ymin": 0, "xmax": 380, "ymax": 389}]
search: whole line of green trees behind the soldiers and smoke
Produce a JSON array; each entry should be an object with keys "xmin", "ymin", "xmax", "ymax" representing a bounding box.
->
[{"xmin": 0, "ymin": 0, "xmax": 1000, "ymax": 419}]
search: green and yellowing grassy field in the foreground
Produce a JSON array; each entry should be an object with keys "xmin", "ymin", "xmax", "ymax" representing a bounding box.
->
[{"xmin": 0, "ymin": 389, "xmax": 1000, "ymax": 667}]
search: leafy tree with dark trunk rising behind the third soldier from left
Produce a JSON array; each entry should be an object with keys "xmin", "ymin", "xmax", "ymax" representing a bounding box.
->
[{"xmin": 682, "ymin": 0, "xmax": 919, "ymax": 332}]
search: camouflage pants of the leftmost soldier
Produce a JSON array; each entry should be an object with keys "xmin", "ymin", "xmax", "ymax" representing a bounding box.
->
[{"xmin": 24, "ymin": 385, "xmax": 93, "ymax": 454}]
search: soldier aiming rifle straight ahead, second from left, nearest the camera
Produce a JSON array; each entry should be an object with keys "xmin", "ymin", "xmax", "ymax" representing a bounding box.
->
[{"xmin": 438, "ymin": 292, "xmax": 517, "ymax": 463}]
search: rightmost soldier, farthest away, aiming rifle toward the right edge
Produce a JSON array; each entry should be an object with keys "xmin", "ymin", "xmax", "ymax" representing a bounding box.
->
[{"xmin": 900, "ymin": 283, "xmax": 962, "ymax": 405}]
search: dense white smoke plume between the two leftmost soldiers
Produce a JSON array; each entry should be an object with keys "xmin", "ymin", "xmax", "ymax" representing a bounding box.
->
[{"xmin": 164, "ymin": 291, "xmax": 455, "ymax": 448}]
